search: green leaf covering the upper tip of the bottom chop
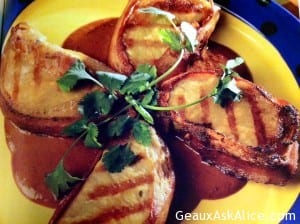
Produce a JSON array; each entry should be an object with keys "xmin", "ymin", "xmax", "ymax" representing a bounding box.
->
[{"xmin": 133, "ymin": 121, "xmax": 152, "ymax": 146}]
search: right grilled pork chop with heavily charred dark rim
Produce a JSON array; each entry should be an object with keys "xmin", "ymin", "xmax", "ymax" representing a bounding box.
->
[{"xmin": 159, "ymin": 72, "xmax": 300, "ymax": 185}]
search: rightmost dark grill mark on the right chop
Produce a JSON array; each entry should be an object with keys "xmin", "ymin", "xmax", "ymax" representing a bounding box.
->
[{"xmin": 247, "ymin": 94, "xmax": 266, "ymax": 145}]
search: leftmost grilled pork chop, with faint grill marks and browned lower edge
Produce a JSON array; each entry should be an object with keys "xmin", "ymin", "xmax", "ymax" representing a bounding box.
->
[{"xmin": 0, "ymin": 23, "xmax": 111, "ymax": 135}]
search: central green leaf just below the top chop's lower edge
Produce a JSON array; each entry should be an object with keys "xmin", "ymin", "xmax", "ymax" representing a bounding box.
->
[{"xmin": 120, "ymin": 72, "xmax": 152, "ymax": 95}]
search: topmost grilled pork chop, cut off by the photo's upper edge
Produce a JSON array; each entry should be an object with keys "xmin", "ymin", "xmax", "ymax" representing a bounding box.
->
[{"xmin": 108, "ymin": 0, "xmax": 219, "ymax": 74}]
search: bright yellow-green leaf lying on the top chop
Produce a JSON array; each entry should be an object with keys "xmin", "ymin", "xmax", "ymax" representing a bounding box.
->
[{"xmin": 159, "ymin": 29, "xmax": 184, "ymax": 52}]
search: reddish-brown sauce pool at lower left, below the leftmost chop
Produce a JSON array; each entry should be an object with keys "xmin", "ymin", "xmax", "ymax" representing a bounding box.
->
[{"xmin": 5, "ymin": 120, "xmax": 99, "ymax": 207}]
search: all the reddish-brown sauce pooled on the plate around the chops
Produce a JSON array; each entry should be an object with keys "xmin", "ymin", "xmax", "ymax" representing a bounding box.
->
[{"xmin": 5, "ymin": 18, "xmax": 251, "ymax": 217}]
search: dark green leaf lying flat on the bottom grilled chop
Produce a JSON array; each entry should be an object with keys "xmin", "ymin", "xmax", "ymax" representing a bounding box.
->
[{"xmin": 102, "ymin": 144, "xmax": 136, "ymax": 173}]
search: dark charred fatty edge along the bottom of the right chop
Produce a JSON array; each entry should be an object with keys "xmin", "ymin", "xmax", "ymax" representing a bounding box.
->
[{"xmin": 178, "ymin": 124, "xmax": 298, "ymax": 185}]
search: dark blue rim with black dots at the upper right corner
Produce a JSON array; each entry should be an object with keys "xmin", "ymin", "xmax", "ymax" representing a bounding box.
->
[{"xmin": 216, "ymin": 0, "xmax": 300, "ymax": 85}]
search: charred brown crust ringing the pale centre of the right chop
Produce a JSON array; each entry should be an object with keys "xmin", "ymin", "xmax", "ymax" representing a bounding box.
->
[{"xmin": 159, "ymin": 72, "xmax": 300, "ymax": 185}]
